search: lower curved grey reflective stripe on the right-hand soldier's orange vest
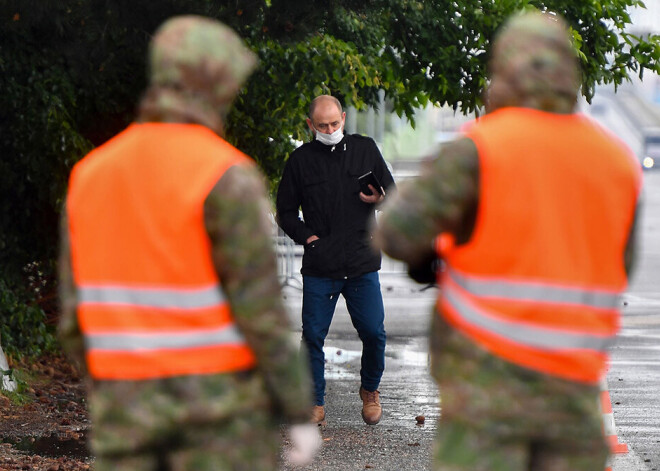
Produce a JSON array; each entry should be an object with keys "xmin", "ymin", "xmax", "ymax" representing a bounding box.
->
[{"xmin": 442, "ymin": 284, "xmax": 614, "ymax": 351}]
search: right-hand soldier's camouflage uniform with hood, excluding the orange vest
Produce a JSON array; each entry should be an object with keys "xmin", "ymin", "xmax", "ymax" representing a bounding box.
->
[{"xmin": 375, "ymin": 13, "xmax": 634, "ymax": 471}]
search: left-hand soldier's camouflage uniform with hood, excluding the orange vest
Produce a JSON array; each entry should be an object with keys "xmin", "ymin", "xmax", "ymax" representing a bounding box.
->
[{"xmin": 59, "ymin": 17, "xmax": 311, "ymax": 471}]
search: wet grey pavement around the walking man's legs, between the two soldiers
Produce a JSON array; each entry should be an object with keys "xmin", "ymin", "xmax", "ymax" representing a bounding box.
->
[{"xmin": 282, "ymin": 275, "xmax": 440, "ymax": 471}]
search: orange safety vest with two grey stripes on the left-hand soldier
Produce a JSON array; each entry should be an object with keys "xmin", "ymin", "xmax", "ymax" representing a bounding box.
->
[{"xmin": 67, "ymin": 123, "xmax": 256, "ymax": 380}]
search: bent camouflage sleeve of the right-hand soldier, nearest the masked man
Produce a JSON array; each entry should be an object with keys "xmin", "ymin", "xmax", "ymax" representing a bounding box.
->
[{"xmin": 374, "ymin": 138, "xmax": 479, "ymax": 266}]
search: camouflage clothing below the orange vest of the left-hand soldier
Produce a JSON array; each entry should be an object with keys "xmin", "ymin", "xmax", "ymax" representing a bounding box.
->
[{"xmin": 89, "ymin": 373, "xmax": 281, "ymax": 471}]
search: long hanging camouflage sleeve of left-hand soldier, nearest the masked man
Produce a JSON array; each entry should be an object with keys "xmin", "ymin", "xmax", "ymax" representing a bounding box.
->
[{"xmin": 204, "ymin": 166, "xmax": 311, "ymax": 422}]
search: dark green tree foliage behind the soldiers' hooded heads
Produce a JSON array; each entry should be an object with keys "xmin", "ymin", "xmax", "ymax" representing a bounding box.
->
[{"xmin": 0, "ymin": 0, "xmax": 660, "ymax": 354}]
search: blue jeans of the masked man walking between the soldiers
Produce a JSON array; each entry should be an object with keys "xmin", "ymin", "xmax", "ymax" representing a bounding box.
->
[{"xmin": 302, "ymin": 271, "xmax": 385, "ymax": 406}]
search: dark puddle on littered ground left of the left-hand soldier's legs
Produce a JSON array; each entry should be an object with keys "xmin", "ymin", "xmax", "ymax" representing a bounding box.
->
[{"xmin": 0, "ymin": 432, "xmax": 90, "ymax": 459}]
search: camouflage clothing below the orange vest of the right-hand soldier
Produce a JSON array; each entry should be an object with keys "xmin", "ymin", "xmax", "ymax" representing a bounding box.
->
[{"xmin": 430, "ymin": 312, "xmax": 608, "ymax": 471}]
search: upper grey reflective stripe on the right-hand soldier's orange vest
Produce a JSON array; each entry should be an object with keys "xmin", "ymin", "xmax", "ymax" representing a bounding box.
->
[{"xmin": 448, "ymin": 270, "xmax": 621, "ymax": 309}]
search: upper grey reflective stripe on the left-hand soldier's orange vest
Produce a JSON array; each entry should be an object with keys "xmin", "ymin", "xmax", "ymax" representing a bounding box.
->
[{"xmin": 78, "ymin": 285, "xmax": 225, "ymax": 309}]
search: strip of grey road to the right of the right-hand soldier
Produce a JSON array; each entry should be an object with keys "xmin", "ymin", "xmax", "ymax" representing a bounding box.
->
[{"xmin": 608, "ymin": 170, "xmax": 660, "ymax": 471}]
